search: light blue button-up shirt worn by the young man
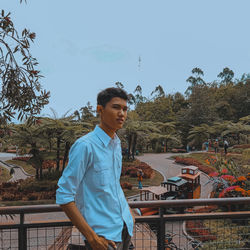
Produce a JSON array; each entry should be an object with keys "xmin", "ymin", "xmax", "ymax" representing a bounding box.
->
[{"xmin": 56, "ymin": 126, "xmax": 133, "ymax": 242}]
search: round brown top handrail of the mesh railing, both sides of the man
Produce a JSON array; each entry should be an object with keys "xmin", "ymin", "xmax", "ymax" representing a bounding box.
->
[{"xmin": 0, "ymin": 197, "xmax": 250, "ymax": 215}]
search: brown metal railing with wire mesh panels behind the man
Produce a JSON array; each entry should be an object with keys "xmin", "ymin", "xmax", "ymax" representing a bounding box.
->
[{"xmin": 0, "ymin": 198, "xmax": 250, "ymax": 250}]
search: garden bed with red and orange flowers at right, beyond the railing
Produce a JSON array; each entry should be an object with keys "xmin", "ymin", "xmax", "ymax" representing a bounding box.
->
[{"xmin": 175, "ymin": 144, "xmax": 250, "ymax": 249}]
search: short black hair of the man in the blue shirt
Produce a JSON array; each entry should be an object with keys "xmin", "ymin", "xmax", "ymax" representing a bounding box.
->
[{"xmin": 97, "ymin": 88, "xmax": 128, "ymax": 108}]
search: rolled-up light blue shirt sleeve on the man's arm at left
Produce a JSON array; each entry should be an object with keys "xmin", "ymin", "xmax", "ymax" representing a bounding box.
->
[{"xmin": 56, "ymin": 140, "xmax": 91, "ymax": 205}]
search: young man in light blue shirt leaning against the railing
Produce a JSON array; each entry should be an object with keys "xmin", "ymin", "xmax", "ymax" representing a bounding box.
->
[{"xmin": 56, "ymin": 88, "xmax": 133, "ymax": 250}]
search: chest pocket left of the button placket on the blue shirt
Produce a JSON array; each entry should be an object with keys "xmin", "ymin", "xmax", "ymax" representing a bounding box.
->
[{"xmin": 94, "ymin": 162, "xmax": 110, "ymax": 186}]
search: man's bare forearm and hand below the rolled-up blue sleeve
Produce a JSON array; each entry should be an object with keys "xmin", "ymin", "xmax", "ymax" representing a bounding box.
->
[{"xmin": 61, "ymin": 201, "xmax": 116, "ymax": 250}]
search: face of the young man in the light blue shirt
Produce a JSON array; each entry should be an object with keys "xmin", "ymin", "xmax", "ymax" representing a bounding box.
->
[{"xmin": 97, "ymin": 97, "xmax": 128, "ymax": 131}]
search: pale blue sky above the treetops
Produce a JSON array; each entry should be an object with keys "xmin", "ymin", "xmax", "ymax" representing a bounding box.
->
[{"xmin": 0, "ymin": 0, "xmax": 250, "ymax": 116}]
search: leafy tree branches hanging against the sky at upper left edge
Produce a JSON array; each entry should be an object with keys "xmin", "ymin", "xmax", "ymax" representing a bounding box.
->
[{"xmin": 0, "ymin": 9, "xmax": 50, "ymax": 120}]
